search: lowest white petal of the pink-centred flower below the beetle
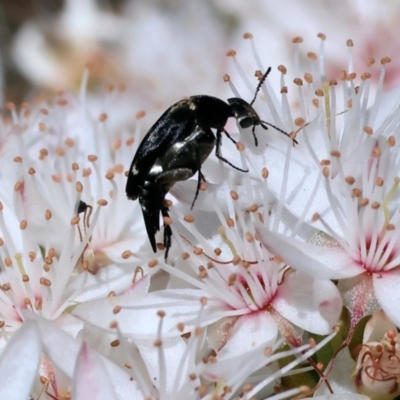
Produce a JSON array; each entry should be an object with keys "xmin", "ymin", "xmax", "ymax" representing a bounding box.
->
[{"xmin": 218, "ymin": 311, "xmax": 278, "ymax": 358}]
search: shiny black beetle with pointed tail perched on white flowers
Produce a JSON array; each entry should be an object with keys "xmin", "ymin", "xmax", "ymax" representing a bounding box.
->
[{"xmin": 126, "ymin": 68, "xmax": 289, "ymax": 258}]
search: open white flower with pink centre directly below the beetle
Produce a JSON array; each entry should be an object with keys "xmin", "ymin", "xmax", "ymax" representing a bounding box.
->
[{"xmin": 74, "ymin": 198, "xmax": 342, "ymax": 376}]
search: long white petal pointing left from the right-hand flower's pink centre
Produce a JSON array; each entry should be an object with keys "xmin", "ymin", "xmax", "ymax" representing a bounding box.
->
[{"xmin": 256, "ymin": 224, "xmax": 364, "ymax": 279}]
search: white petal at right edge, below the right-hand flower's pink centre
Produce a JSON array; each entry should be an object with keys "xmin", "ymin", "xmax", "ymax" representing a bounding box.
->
[{"xmin": 372, "ymin": 268, "xmax": 400, "ymax": 327}]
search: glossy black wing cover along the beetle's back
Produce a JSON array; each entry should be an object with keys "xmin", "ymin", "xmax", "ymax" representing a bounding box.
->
[{"xmin": 126, "ymin": 100, "xmax": 196, "ymax": 200}]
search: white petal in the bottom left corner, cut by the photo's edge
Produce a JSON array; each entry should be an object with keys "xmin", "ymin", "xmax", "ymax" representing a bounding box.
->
[{"xmin": 0, "ymin": 322, "xmax": 42, "ymax": 400}]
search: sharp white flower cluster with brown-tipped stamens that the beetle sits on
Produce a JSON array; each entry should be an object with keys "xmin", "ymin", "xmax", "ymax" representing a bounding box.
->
[{"xmin": 0, "ymin": 34, "xmax": 400, "ymax": 400}]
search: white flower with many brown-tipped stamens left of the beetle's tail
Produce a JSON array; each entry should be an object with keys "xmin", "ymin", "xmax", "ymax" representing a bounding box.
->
[{"xmin": 0, "ymin": 85, "xmax": 144, "ymax": 337}]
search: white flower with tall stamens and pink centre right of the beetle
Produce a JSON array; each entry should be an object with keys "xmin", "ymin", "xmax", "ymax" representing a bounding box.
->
[{"xmin": 222, "ymin": 32, "xmax": 400, "ymax": 328}]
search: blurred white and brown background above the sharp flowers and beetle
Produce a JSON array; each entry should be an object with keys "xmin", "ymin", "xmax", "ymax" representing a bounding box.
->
[{"xmin": 0, "ymin": 0, "xmax": 400, "ymax": 109}]
